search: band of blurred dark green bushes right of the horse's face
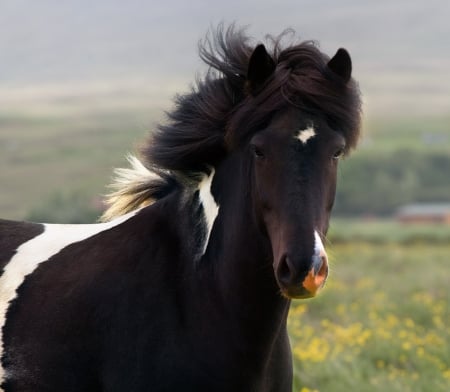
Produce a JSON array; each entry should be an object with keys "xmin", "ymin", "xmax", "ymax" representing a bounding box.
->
[{"xmin": 334, "ymin": 151, "xmax": 450, "ymax": 216}]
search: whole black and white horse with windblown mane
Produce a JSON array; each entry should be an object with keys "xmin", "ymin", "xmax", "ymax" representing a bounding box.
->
[{"xmin": 0, "ymin": 25, "xmax": 361, "ymax": 392}]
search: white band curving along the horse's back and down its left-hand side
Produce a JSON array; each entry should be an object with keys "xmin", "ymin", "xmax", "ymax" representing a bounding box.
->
[{"xmin": 0, "ymin": 210, "xmax": 138, "ymax": 384}]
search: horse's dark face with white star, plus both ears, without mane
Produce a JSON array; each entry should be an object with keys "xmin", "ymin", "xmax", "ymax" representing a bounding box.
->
[{"xmin": 239, "ymin": 46, "xmax": 358, "ymax": 298}]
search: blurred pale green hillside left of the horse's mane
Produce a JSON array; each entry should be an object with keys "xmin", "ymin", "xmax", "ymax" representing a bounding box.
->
[{"xmin": 0, "ymin": 110, "xmax": 156, "ymax": 223}]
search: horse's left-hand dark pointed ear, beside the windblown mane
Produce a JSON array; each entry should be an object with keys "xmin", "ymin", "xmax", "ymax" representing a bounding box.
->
[{"xmin": 247, "ymin": 44, "xmax": 276, "ymax": 95}]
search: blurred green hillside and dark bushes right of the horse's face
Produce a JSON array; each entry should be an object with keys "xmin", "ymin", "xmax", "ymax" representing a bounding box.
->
[{"xmin": 333, "ymin": 117, "xmax": 450, "ymax": 216}]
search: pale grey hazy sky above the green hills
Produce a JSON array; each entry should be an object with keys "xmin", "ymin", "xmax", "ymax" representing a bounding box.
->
[{"xmin": 0, "ymin": 0, "xmax": 450, "ymax": 115}]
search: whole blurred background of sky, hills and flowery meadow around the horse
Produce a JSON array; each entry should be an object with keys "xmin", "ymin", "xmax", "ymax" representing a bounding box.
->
[{"xmin": 0, "ymin": 0, "xmax": 450, "ymax": 392}]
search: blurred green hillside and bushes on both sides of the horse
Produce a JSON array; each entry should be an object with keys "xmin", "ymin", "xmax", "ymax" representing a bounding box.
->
[{"xmin": 0, "ymin": 107, "xmax": 450, "ymax": 222}]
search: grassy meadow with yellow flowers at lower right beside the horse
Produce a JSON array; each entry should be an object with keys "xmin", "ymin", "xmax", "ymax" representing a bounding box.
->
[{"xmin": 289, "ymin": 243, "xmax": 450, "ymax": 392}]
